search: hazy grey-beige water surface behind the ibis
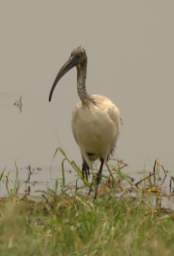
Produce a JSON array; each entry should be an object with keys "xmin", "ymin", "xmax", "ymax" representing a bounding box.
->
[{"xmin": 0, "ymin": 0, "xmax": 174, "ymax": 173}]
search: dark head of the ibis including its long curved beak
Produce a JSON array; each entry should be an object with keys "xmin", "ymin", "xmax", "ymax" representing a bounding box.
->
[{"xmin": 49, "ymin": 46, "xmax": 87, "ymax": 101}]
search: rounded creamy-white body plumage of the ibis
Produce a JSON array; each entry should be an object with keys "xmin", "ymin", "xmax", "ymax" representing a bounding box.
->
[{"xmin": 72, "ymin": 95, "xmax": 120, "ymax": 165}]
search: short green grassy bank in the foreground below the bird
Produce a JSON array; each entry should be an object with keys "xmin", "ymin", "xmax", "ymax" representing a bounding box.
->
[{"xmin": 0, "ymin": 193, "xmax": 174, "ymax": 256}]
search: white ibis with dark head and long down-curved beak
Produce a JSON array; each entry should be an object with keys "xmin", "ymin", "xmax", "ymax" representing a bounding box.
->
[{"xmin": 49, "ymin": 46, "xmax": 121, "ymax": 199}]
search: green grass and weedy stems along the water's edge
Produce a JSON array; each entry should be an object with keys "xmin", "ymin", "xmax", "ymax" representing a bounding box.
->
[{"xmin": 0, "ymin": 149, "xmax": 174, "ymax": 256}]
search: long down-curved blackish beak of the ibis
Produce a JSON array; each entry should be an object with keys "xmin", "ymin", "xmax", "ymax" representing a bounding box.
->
[{"xmin": 49, "ymin": 56, "xmax": 79, "ymax": 101}]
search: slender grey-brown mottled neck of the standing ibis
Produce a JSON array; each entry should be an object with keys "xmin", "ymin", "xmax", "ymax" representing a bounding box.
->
[{"xmin": 77, "ymin": 62, "xmax": 90, "ymax": 103}]
